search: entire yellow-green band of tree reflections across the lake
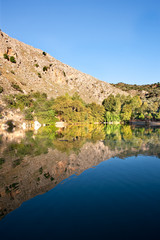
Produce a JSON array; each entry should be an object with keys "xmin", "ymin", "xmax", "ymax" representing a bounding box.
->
[{"xmin": 2, "ymin": 124, "xmax": 160, "ymax": 160}]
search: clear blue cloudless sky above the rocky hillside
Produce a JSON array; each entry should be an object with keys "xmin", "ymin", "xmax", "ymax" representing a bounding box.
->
[{"xmin": 0, "ymin": 0, "xmax": 160, "ymax": 84}]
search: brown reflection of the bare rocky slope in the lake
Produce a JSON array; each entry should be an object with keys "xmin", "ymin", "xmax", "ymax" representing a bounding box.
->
[{"xmin": 0, "ymin": 142, "xmax": 120, "ymax": 220}]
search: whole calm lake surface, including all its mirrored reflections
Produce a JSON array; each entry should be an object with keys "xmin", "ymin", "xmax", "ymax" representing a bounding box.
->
[{"xmin": 0, "ymin": 125, "xmax": 160, "ymax": 240}]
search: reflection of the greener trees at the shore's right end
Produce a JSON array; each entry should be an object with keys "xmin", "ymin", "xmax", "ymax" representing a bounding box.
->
[{"xmin": 104, "ymin": 125, "xmax": 160, "ymax": 157}]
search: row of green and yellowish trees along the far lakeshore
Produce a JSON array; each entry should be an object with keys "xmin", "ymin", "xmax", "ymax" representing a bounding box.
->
[{"xmin": 5, "ymin": 92, "xmax": 160, "ymax": 124}]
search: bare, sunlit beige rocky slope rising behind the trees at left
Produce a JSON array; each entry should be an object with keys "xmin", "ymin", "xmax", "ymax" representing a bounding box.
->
[{"xmin": 0, "ymin": 31, "xmax": 127, "ymax": 103}]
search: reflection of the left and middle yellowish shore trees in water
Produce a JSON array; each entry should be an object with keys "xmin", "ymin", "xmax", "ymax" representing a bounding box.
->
[{"xmin": 3, "ymin": 124, "xmax": 105, "ymax": 159}]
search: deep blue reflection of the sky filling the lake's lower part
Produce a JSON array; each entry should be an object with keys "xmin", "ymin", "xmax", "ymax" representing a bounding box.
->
[{"xmin": 0, "ymin": 156, "xmax": 160, "ymax": 240}]
